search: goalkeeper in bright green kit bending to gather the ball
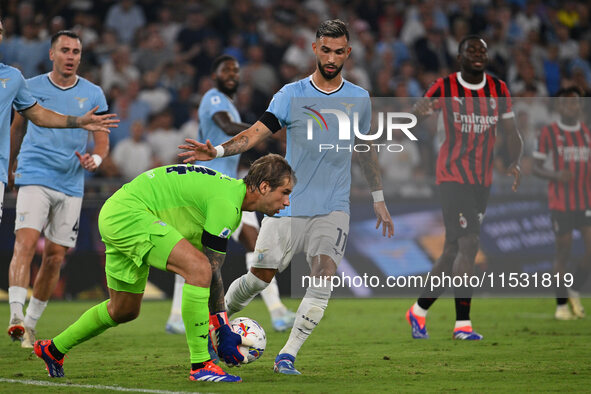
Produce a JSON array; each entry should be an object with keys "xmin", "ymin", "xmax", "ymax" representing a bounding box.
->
[{"xmin": 34, "ymin": 154, "xmax": 295, "ymax": 382}]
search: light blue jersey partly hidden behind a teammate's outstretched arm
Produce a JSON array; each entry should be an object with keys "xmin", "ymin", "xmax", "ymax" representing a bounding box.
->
[{"xmin": 15, "ymin": 74, "xmax": 109, "ymax": 197}]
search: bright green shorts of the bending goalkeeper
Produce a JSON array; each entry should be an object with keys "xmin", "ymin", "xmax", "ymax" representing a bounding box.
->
[{"xmin": 98, "ymin": 191, "xmax": 183, "ymax": 293}]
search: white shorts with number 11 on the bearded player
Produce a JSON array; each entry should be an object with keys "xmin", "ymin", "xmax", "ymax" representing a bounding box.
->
[{"xmin": 253, "ymin": 211, "xmax": 349, "ymax": 272}]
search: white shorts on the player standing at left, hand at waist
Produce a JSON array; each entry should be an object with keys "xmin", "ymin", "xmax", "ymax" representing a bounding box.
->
[{"xmin": 14, "ymin": 185, "xmax": 82, "ymax": 248}]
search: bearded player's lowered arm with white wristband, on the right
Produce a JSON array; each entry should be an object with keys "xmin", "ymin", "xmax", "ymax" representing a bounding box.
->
[{"xmin": 359, "ymin": 143, "xmax": 394, "ymax": 238}]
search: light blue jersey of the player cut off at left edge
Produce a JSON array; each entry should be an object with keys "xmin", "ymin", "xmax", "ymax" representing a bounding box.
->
[{"xmin": 0, "ymin": 63, "xmax": 36, "ymax": 183}]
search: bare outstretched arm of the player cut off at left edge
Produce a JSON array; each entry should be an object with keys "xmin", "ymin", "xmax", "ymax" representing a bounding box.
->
[{"xmin": 22, "ymin": 104, "xmax": 119, "ymax": 133}]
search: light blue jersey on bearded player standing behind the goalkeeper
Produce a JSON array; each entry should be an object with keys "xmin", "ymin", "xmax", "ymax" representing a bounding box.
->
[{"xmin": 267, "ymin": 77, "xmax": 371, "ymax": 216}]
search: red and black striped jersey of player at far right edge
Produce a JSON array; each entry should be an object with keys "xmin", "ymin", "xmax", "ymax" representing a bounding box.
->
[{"xmin": 533, "ymin": 122, "xmax": 591, "ymax": 211}]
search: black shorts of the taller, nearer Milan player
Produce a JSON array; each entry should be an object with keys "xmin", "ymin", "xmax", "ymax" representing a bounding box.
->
[{"xmin": 439, "ymin": 182, "xmax": 490, "ymax": 241}]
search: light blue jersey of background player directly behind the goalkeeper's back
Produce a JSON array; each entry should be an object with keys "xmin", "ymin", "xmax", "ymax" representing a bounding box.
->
[{"xmin": 196, "ymin": 88, "xmax": 241, "ymax": 178}]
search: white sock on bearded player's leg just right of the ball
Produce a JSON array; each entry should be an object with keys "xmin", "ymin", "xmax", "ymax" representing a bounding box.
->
[{"xmin": 279, "ymin": 287, "xmax": 330, "ymax": 357}]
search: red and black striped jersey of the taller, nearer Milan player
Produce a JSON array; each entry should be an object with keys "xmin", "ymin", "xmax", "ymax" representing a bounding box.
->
[{"xmin": 425, "ymin": 72, "xmax": 514, "ymax": 186}]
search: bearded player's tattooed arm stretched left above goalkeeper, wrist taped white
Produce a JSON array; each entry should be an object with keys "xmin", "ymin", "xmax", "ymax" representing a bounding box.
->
[{"xmin": 179, "ymin": 121, "xmax": 271, "ymax": 163}]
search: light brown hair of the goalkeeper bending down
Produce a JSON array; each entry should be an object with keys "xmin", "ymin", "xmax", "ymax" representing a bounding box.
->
[{"xmin": 244, "ymin": 153, "xmax": 297, "ymax": 190}]
